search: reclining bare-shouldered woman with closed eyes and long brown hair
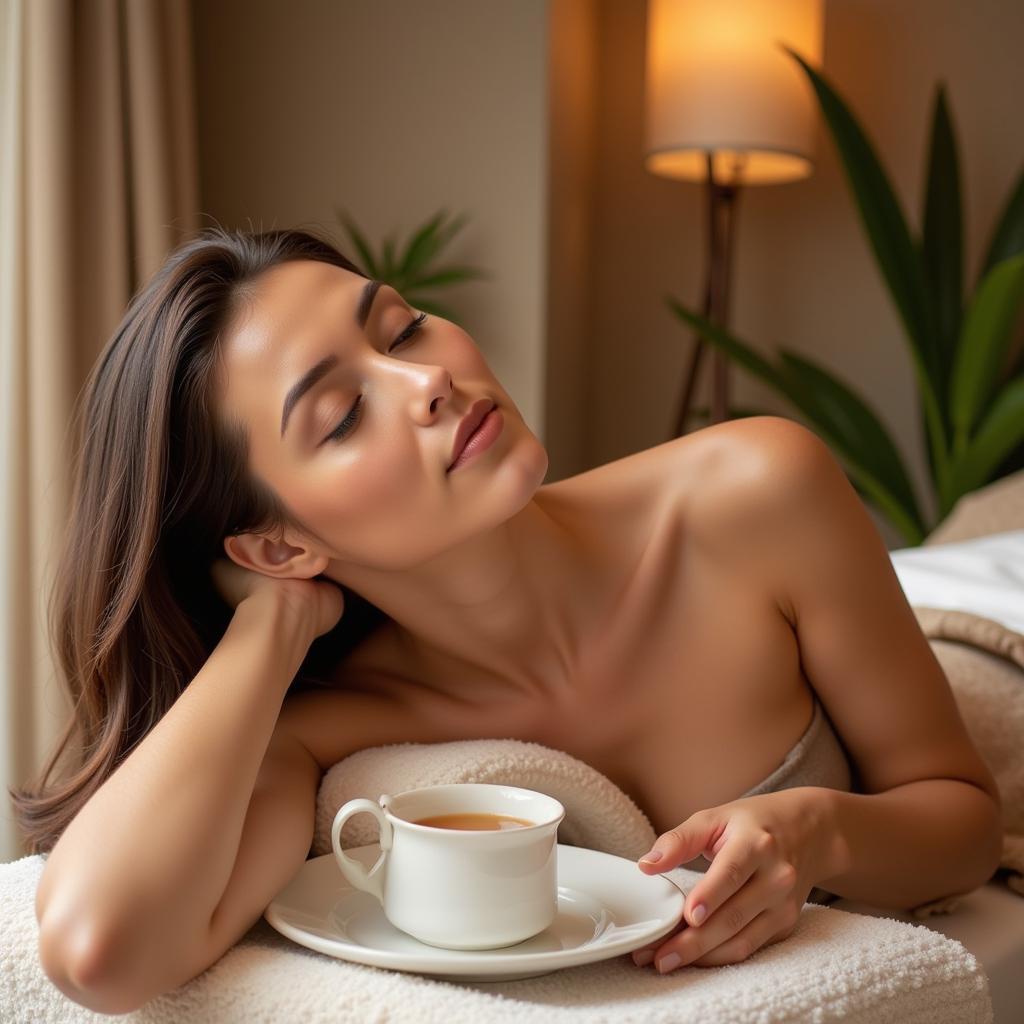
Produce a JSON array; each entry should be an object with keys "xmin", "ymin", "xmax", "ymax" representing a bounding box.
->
[{"xmin": 14, "ymin": 229, "xmax": 1000, "ymax": 1013}]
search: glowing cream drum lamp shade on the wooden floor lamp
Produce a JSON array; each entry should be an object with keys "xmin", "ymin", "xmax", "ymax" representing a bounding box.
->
[{"xmin": 644, "ymin": 0, "xmax": 823, "ymax": 184}]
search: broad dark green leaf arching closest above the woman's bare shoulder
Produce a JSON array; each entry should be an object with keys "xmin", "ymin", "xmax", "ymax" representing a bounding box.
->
[{"xmin": 779, "ymin": 348, "xmax": 924, "ymax": 530}]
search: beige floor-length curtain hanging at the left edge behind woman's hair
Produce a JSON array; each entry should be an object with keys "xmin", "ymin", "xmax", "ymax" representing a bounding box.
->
[{"xmin": 0, "ymin": 0, "xmax": 199, "ymax": 862}]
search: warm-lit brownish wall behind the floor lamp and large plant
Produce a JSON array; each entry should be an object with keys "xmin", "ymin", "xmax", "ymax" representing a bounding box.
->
[{"xmin": 569, "ymin": 0, "xmax": 1024, "ymax": 548}]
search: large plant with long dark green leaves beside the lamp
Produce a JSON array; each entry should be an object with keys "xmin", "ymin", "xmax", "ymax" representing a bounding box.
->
[{"xmin": 667, "ymin": 47, "xmax": 1024, "ymax": 545}]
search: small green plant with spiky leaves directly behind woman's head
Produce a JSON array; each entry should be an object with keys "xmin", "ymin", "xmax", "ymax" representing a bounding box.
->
[{"xmin": 336, "ymin": 203, "xmax": 489, "ymax": 324}]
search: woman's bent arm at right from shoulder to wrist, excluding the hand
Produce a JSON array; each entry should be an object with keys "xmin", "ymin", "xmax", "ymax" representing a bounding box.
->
[{"xmin": 709, "ymin": 417, "xmax": 1001, "ymax": 907}]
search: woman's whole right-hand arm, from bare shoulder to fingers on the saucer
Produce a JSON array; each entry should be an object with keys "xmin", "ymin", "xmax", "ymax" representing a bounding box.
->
[{"xmin": 634, "ymin": 416, "xmax": 1001, "ymax": 971}]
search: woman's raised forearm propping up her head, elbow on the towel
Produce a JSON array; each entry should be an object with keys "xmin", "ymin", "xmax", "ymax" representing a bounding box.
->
[{"xmin": 36, "ymin": 589, "xmax": 314, "ymax": 1012}]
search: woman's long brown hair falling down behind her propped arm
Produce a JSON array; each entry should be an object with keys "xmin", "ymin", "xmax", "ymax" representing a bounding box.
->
[{"xmin": 8, "ymin": 227, "xmax": 387, "ymax": 853}]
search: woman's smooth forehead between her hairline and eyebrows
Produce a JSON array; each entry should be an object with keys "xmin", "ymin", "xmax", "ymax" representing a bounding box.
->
[{"xmin": 221, "ymin": 260, "xmax": 366, "ymax": 419}]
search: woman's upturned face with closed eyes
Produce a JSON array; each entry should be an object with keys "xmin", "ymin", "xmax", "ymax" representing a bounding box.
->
[{"xmin": 220, "ymin": 260, "xmax": 548, "ymax": 570}]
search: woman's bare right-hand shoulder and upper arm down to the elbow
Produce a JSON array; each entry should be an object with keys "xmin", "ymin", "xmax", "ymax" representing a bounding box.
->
[{"xmin": 679, "ymin": 417, "xmax": 998, "ymax": 801}]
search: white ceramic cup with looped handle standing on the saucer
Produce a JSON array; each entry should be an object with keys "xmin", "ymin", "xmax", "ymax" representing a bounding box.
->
[{"xmin": 331, "ymin": 782, "xmax": 565, "ymax": 949}]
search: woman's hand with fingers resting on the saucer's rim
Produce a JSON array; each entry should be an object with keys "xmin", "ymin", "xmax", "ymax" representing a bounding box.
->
[{"xmin": 633, "ymin": 786, "xmax": 836, "ymax": 974}]
